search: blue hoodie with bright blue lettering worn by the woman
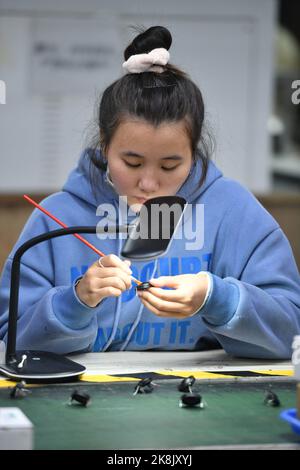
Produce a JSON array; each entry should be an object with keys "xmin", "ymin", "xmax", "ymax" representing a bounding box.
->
[{"xmin": 0, "ymin": 152, "xmax": 300, "ymax": 359}]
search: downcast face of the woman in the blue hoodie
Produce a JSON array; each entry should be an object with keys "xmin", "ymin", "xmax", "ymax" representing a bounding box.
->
[{"xmin": 105, "ymin": 119, "xmax": 192, "ymax": 211}]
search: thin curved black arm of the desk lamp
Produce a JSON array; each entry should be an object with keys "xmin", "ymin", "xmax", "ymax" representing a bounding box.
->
[{"xmin": 6, "ymin": 225, "xmax": 128, "ymax": 364}]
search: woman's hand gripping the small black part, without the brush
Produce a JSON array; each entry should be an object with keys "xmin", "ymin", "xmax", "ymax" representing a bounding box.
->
[{"xmin": 137, "ymin": 273, "xmax": 209, "ymax": 318}]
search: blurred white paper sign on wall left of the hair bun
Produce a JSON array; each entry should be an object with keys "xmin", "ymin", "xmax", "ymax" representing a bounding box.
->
[{"xmin": 29, "ymin": 18, "xmax": 122, "ymax": 95}]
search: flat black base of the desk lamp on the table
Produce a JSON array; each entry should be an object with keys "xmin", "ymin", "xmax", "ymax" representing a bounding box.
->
[{"xmin": 0, "ymin": 351, "xmax": 86, "ymax": 382}]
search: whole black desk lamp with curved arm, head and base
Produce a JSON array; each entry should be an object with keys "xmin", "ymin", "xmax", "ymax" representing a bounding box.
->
[{"xmin": 0, "ymin": 196, "xmax": 186, "ymax": 382}]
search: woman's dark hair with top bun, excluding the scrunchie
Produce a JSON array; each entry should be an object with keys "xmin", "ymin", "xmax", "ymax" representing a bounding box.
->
[{"xmin": 89, "ymin": 26, "xmax": 209, "ymax": 189}]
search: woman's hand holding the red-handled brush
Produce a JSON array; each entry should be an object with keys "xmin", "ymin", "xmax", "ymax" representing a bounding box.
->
[{"xmin": 76, "ymin": 255, "xmax": 132, "ymax": 307}]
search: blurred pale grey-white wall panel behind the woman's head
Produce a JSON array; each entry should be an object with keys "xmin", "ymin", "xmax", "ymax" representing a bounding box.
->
[{"xmin": 0, "ymin": 0, "xmax": 276, "ymax": 193}]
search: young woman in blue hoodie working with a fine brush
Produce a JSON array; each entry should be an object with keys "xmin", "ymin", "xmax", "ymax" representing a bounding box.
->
[{"xmin": 0, "ymin": 26, "xmax": 300, "ymax": 358}]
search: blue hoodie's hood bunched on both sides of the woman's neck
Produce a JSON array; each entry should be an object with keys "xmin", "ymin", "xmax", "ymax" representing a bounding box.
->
[{"xmin": 62, "ymin": 149, "xmax": 222, "ymax": 207}]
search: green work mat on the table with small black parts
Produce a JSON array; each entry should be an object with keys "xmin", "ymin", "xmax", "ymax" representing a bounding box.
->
[{"xmin": 0, "ymin": 379, "xmax": 300, "ymax": 449}]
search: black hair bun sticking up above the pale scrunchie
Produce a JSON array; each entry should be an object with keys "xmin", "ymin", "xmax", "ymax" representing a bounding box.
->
[{"xmin": 124, "ymin": 26, "xmax": 172, "ymax": 60}]
